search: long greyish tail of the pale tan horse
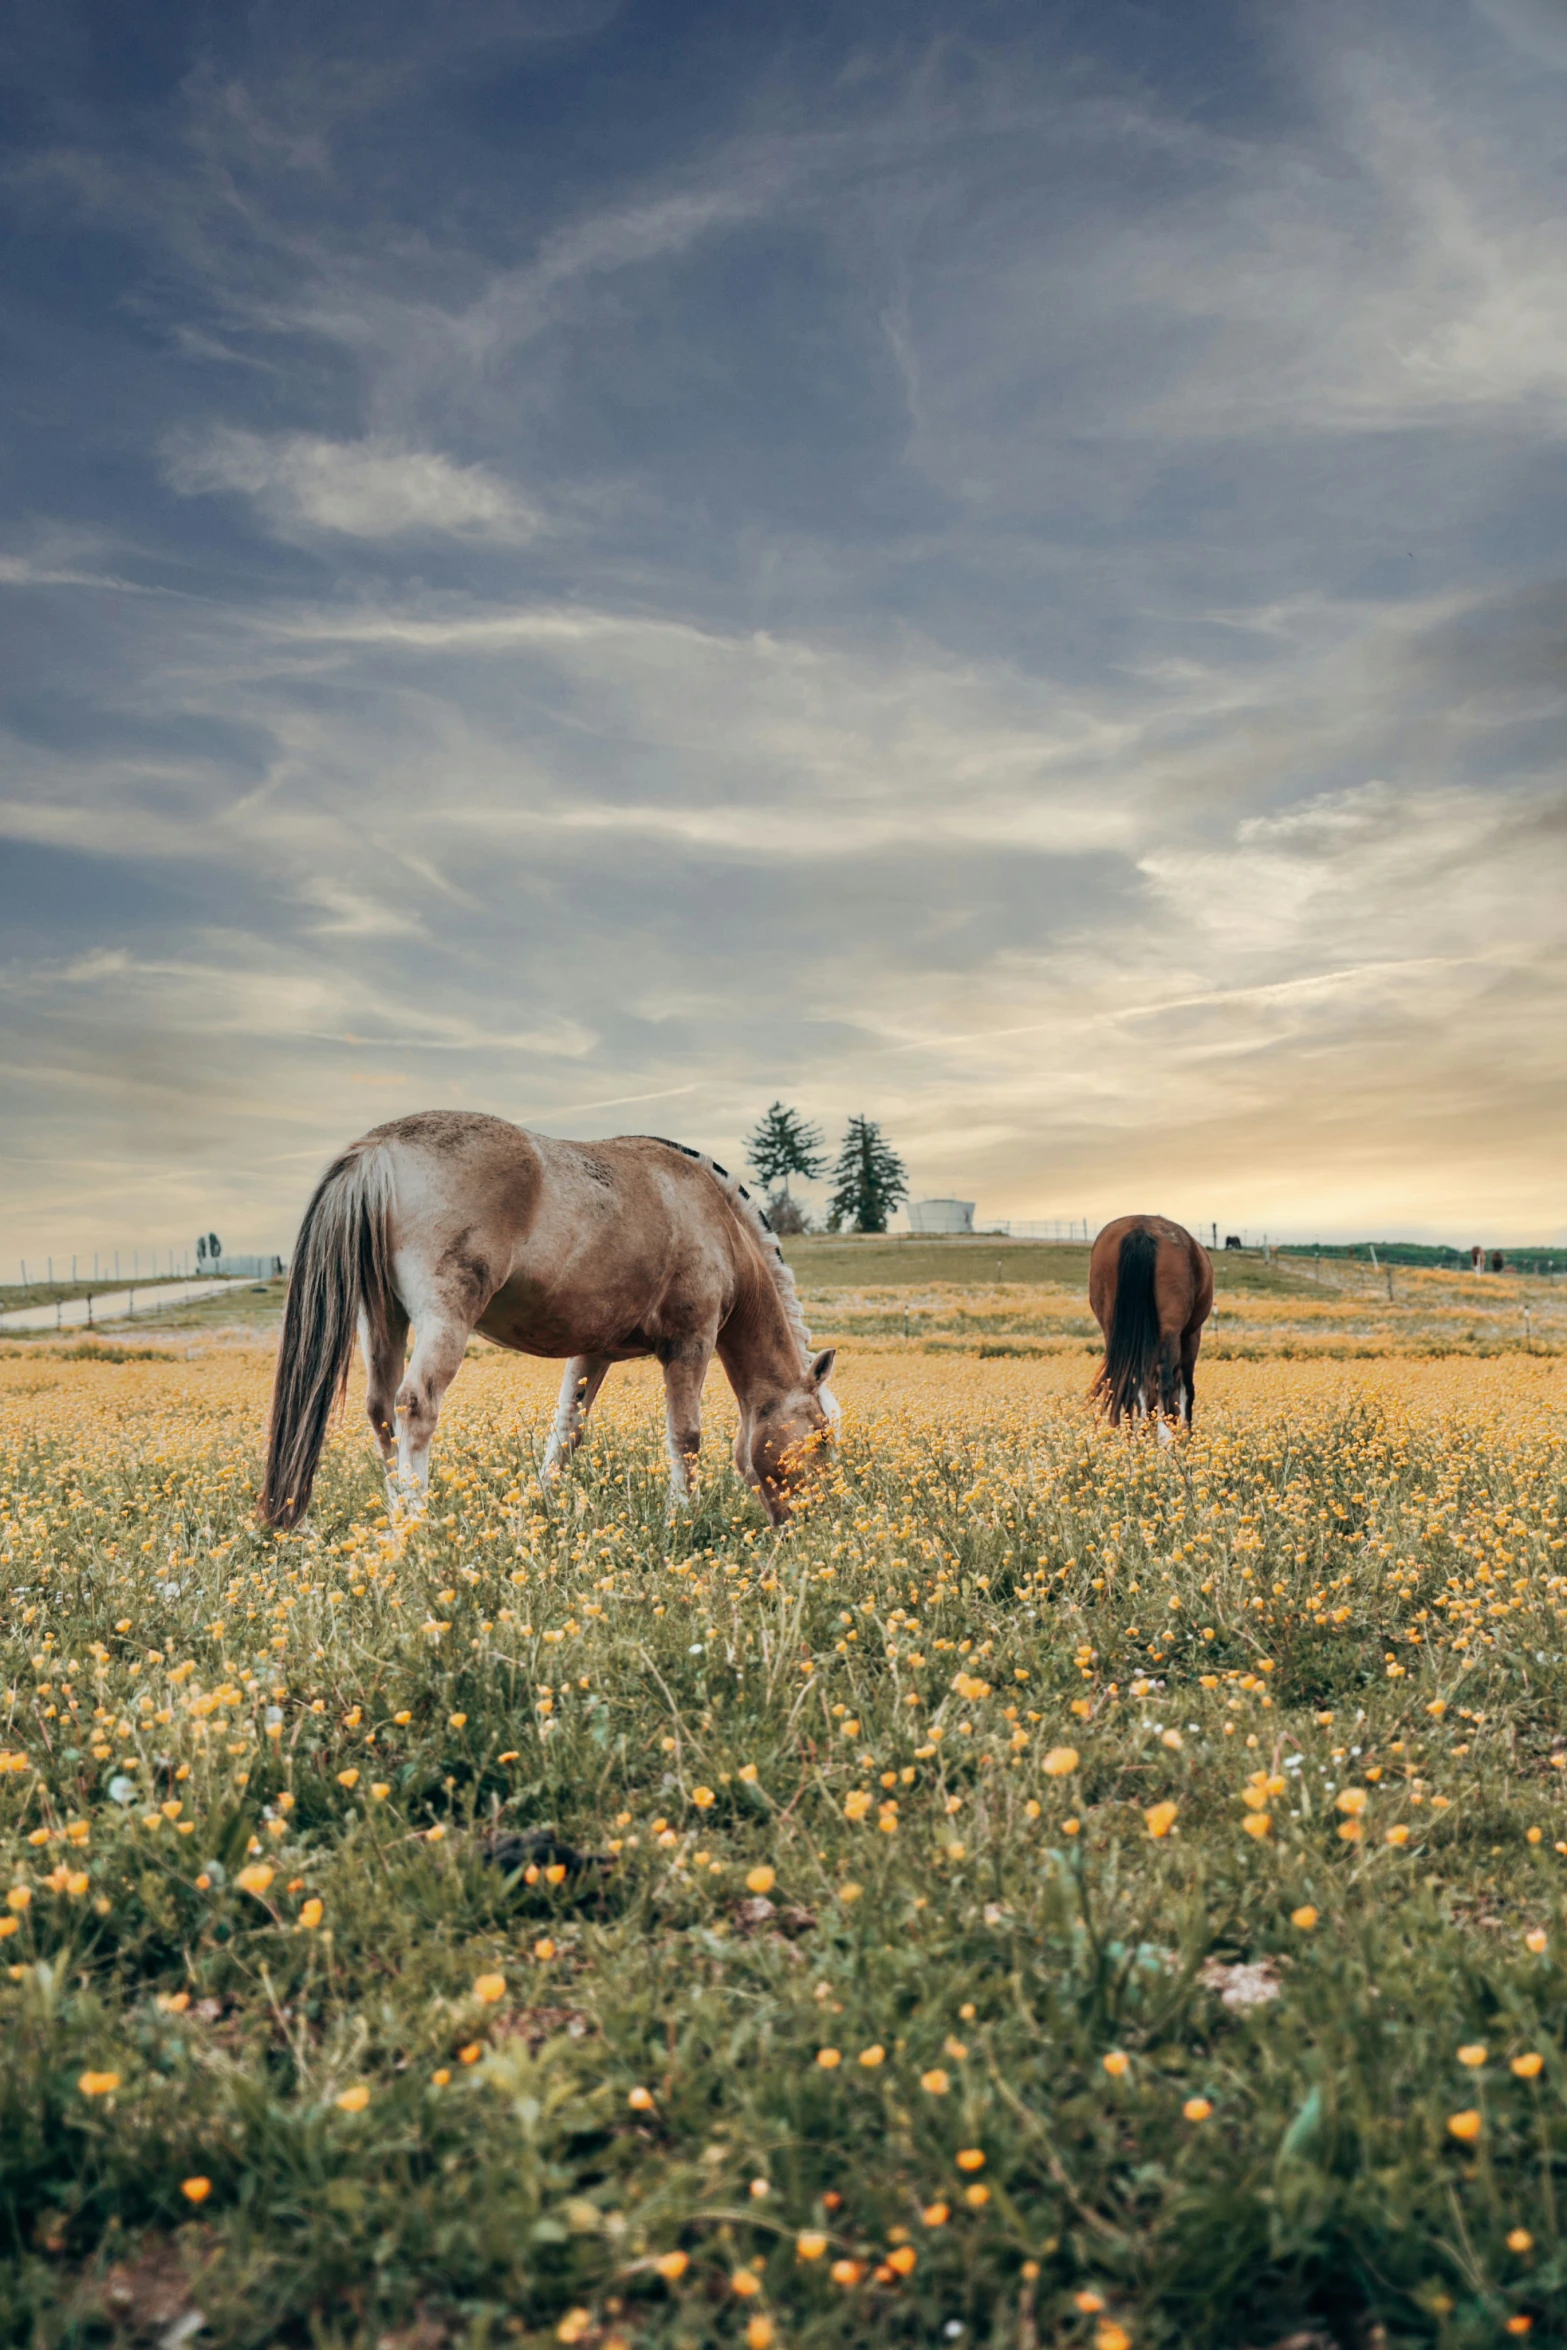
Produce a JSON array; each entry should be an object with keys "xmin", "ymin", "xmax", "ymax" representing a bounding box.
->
[{"xmin": 261, "ymin": 1144, "xmax": 392, "ymax": 1525}]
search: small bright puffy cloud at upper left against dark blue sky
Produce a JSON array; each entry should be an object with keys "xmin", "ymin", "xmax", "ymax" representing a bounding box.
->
[{"xmin": 167, "ymin": 425, "xmax": 540, "ymax": 545}]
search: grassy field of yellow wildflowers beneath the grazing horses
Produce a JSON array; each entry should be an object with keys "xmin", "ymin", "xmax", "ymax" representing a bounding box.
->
[{"xmin": 0, "ymin": 1325, "xmax": 1567, "ymax": 2350}]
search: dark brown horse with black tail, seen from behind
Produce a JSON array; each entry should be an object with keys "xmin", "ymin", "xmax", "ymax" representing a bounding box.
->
[{"xmin": 1088, "ymin": 1215, "xmax": 1212, "ymax": 1426}]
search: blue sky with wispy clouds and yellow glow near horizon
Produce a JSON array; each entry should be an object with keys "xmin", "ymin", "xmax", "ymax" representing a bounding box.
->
[{"xmin": 0, "ymin": 0, "xmax": 1567, "ymax": 1278}]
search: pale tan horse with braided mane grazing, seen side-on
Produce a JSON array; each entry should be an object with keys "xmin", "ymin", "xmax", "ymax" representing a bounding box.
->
[{"xmin": 261, "ymin": 1109, "xmax": 839, "ymax": 1525}]
